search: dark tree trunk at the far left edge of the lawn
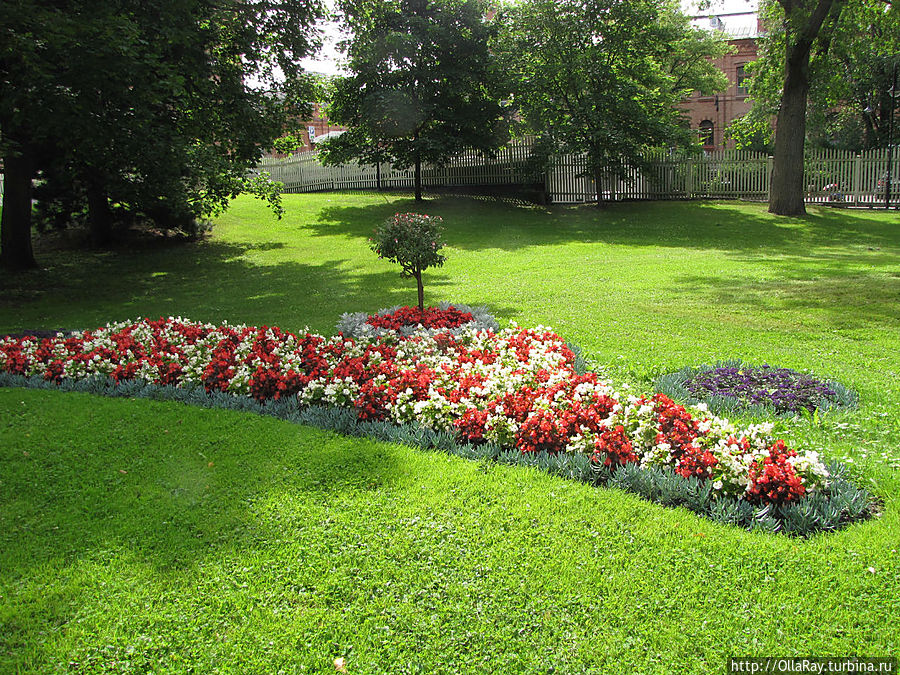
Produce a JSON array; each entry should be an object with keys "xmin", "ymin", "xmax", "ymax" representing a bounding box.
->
[{"xmin": 0, "ymin": 151, "xmax": 37, "ymax": 270}]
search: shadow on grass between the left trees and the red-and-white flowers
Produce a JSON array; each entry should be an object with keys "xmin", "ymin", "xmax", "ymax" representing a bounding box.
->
[{"xmin": 0, "ymin": 241, "xmax": 514, "ymax": 334}]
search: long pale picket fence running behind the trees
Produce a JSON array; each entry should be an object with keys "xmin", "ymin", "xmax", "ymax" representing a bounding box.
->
[{"xmin": 257, "ymin": 143, "xmax": 900, "ymax": 207}]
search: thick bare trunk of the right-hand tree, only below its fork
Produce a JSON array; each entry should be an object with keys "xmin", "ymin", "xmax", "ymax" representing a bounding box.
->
[{"xmin": 769, "ymin": 47, "xmax": 809, "ymax": 216}]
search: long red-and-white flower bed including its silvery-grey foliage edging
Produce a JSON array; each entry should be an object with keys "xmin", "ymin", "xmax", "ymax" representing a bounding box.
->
[{"xmin": 0, "ymin": 318, "xmax": 870, "ymax": 534}]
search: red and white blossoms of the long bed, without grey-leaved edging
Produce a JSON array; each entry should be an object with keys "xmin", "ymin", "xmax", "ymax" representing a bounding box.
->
[{"xmin": 0, "ymin": 319, "xmax": 872, "ymax": 532}]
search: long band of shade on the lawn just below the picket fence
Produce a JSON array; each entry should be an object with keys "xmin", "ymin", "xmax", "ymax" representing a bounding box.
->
[{"xmin": 305, "ymin": 197, "xmax": 900, "ymax": 253}]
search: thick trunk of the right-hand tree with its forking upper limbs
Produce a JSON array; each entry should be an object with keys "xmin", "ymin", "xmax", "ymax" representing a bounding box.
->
[{"xmin": 769, "ymin": 0, "xmax": 847, "ymax": 216}]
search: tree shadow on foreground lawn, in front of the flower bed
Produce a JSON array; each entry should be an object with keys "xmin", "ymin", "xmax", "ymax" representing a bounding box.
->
[{"xmin": 0, "ymin": 390, "xmax": 402, "ymax": 583}]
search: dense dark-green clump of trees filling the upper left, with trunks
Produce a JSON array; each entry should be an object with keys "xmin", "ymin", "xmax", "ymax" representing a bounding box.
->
[{"xmin": 0, "ymin": 0, "xmax": 319, "ymax": 269}]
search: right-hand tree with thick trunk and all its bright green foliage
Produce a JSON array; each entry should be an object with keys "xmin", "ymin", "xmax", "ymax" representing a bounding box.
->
[{"xmin": 733, "ymin": 0, "xmax": 900, "ymax": 215}]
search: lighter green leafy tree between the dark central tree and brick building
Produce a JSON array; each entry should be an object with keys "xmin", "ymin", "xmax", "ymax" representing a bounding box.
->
[{"xmin": 498, "ymin": 0, "xmax": 727, "ymax": 205}]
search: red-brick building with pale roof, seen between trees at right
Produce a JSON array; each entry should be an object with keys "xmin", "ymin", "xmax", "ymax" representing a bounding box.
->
[{"xmin": 682, "ymin": 12, "xmax": 759, "ymax": 150}]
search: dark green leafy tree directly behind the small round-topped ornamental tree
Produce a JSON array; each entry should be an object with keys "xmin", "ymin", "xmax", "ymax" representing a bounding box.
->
[{"xmin": 323, "ymin": 0, "xmax": 506, "ymax": 201}]
